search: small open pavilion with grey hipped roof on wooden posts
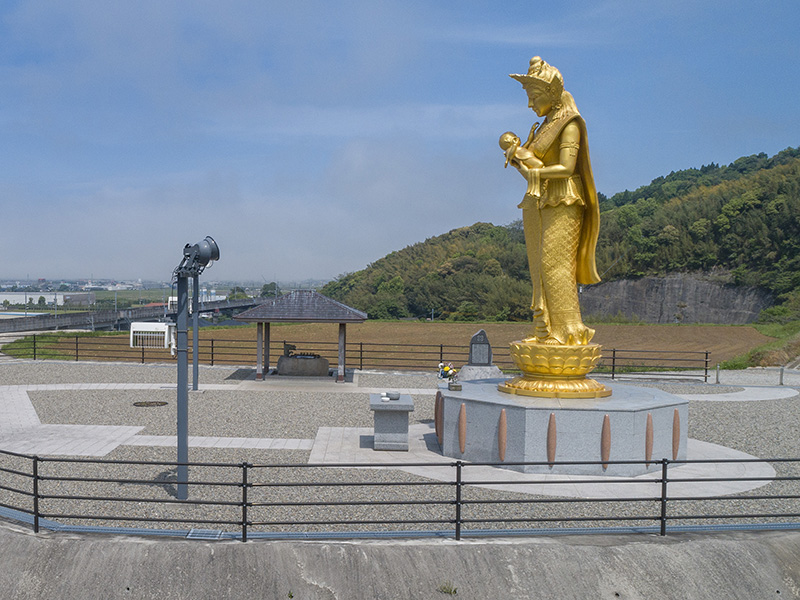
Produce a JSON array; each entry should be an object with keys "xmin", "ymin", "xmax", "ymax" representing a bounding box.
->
[{"xmin": 233, "ymin": 290, "xmax": 367, "ymax": 381}]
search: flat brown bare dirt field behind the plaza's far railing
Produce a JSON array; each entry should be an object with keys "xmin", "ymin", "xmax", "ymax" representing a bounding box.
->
[{"xmin": 6, "ymin": 321, "xmax": 768, "ymax": 369}]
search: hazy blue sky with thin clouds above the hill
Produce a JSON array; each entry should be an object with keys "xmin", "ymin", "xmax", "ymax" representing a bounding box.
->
[{"xmin": 0, "ymin": 0, "xmax": 800, "ymax": 281}]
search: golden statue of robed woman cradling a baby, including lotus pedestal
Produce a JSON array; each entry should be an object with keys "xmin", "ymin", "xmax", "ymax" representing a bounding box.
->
[{"xmin": 500, "ymin": 56, "xmax": 611, "ymax": 398}]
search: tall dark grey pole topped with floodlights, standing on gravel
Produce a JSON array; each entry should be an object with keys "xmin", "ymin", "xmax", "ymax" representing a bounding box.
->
[{"xmin": 172, "ymin": 235, "xmax": 219, "ymax": 500}]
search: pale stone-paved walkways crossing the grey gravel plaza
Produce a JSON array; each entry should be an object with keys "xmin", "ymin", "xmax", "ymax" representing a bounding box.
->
[{"xmin": 0, "ymin": 381, "xmax": 780, "ymax": 498}]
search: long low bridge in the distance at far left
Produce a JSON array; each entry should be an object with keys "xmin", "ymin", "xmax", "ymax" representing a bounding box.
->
[{"xmin": 0, "ymin": 298, "xmax": 264, "ymax": 333}]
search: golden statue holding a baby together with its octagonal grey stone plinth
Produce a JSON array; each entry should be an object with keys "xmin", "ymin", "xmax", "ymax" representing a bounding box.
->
[{"xmin": 434, "ymin": 56, "xmax": 688, "ymax": 476}]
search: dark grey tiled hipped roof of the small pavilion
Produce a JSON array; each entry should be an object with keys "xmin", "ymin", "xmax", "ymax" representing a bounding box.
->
[{"xmin": 233, "ymin": 290, "xmax": 367, "ymax": 323}]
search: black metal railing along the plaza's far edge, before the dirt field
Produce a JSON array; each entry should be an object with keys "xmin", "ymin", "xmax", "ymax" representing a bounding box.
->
[{"xmin": 7, "ymin": 334, "xmax": 709, "ymax": 381}]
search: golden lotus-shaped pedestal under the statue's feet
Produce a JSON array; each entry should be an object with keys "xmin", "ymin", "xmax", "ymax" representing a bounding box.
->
[{"xmin": 497, "ymin": 340, "xmax": 611, "ymax": 398}]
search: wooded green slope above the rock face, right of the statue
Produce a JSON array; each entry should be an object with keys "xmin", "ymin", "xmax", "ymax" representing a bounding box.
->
[{"xmin": 598, "ymin": 159, "xmax": 800, "ymax": 296}]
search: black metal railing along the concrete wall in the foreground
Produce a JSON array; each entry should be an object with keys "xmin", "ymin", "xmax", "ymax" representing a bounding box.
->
[{"xmin": 0, "ymin": 452, "xmax": 800, "ymax": 541}]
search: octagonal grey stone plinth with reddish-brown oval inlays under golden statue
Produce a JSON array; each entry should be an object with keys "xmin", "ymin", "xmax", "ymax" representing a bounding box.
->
[{"xmin": 438, "ymin": 379, "xmax": 689, "ymax": 476}]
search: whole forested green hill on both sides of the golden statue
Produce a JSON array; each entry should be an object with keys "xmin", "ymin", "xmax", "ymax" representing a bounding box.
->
[{"xmin": 321, "ymin": 148, "xmax": 800, "ymax": 320}]
